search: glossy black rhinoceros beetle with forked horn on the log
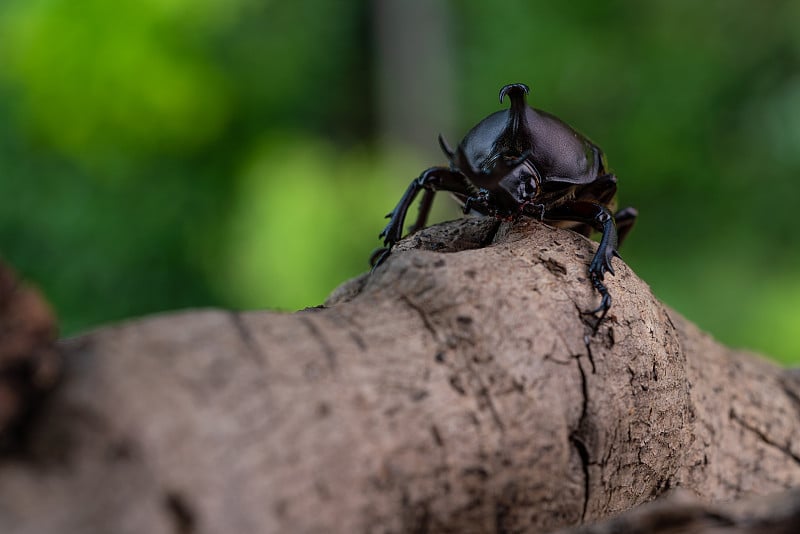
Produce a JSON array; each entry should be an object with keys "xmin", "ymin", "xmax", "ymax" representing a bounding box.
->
[{"xmin": 371, "ymin": 83, "xmax": 637, "ymax": 325}]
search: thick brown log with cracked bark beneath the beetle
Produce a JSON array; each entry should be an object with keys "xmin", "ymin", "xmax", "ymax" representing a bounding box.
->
[{"xmin": 0, "ymin": 219, "xmax": 800, "ymax": 534}]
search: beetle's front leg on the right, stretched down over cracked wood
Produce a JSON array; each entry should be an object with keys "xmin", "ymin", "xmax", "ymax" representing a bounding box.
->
[{"xmin": 545, "ymin": 200, "xmax": 619, "ymax": 325}]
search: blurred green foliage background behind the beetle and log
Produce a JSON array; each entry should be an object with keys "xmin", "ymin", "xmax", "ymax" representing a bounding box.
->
[{"xmin": 0, "ymin": 0, "xmax": 800, "ymax": 363}]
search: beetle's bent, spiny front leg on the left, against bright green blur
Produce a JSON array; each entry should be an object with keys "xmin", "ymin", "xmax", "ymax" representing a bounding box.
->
[{"xmin": 370, "ymin": 167, "xmax": 468, "ymax": 269}]
